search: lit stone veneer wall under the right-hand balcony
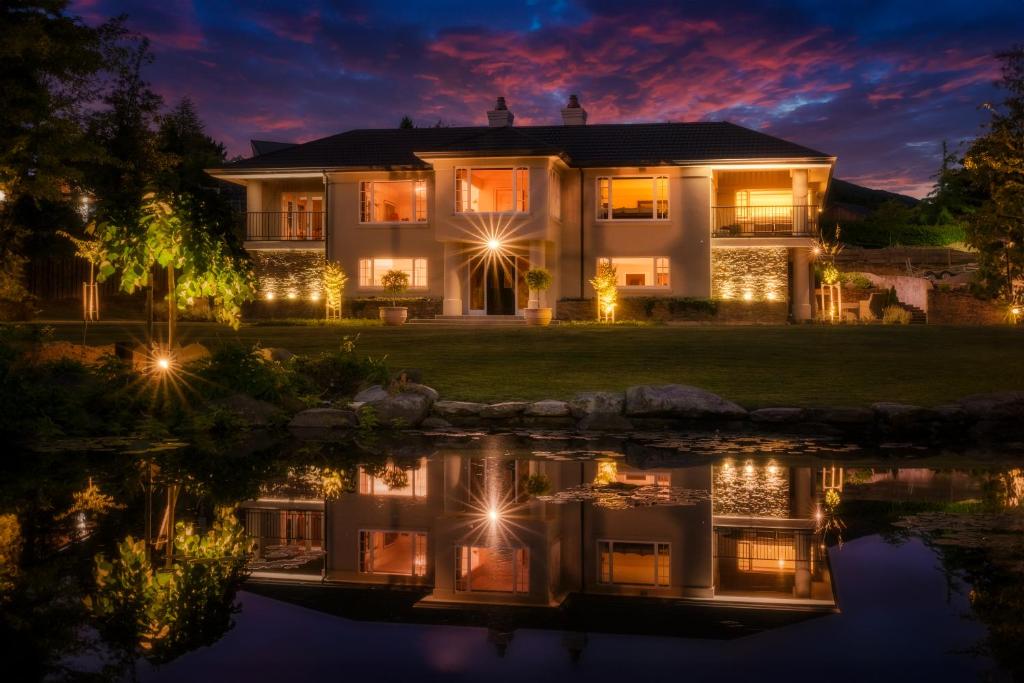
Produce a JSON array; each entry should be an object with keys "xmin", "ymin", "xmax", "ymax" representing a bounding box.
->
[{"xmin": 711, "ymin": 247, "xmax": 790, "ymax": 301}]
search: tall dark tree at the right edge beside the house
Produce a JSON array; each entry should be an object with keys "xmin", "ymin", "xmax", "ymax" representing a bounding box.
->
[{"xmin": 964, "ymin": 46, "xmax": 1024, "ymax": 301}]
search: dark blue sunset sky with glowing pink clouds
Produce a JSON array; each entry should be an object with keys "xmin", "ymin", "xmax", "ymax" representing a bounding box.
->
[{"xmin": 70, "ymin": 0, "xmax": 1024, "ymax": 197}]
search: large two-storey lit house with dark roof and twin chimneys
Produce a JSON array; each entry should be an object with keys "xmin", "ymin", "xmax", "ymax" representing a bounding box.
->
[{"xmin": 209, "ymin": 96, "xmax": 836, "ymax": 321}]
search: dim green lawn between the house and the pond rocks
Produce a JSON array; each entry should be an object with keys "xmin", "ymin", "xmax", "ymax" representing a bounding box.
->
[{"xmin": 32, "ymin": 324, "xmax": 1024, "ymax": 408}]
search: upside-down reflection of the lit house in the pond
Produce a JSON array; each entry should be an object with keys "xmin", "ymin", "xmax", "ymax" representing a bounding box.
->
[{"xmin": 239, "ymin": 450, "xmax": 835, "ymax": 609}]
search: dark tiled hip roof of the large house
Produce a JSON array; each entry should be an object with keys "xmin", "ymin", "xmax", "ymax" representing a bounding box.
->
[{"xmin": 211, "ymin": 122, "xmax": 833, "ymax": 174}]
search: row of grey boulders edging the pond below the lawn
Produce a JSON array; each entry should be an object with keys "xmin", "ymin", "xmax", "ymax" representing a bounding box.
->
[{"xmin": 289, "ymin": 383, "xmax": 1024, "ymax": 444}]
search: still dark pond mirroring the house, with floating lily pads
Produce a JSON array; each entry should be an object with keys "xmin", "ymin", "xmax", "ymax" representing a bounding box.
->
[{"xmin": 0, "ymin": 433, "xmax": 1024, "ymax": 681}]
